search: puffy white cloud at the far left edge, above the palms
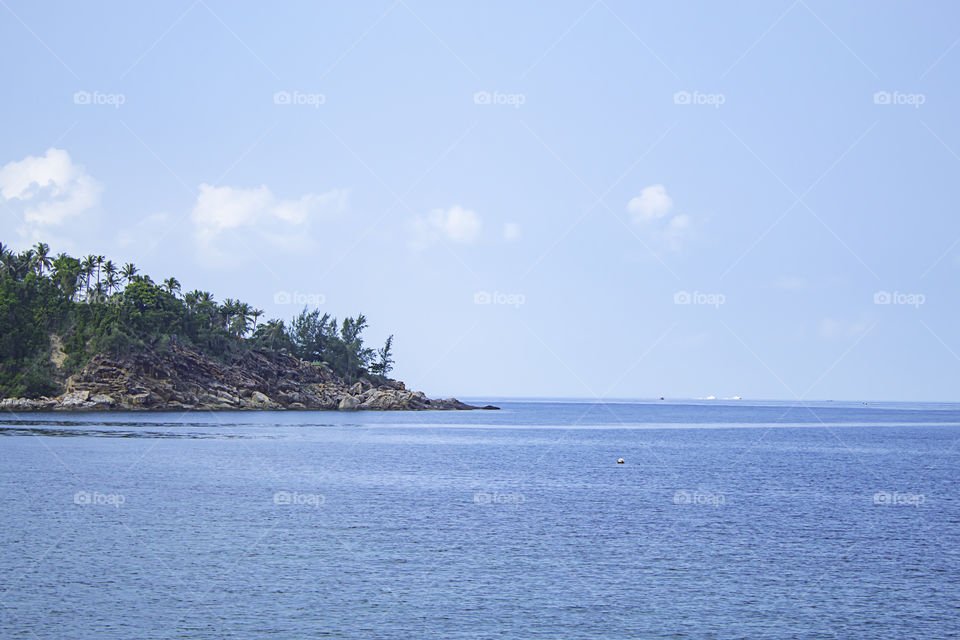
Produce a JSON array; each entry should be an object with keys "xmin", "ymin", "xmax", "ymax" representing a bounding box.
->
[{"xmin": 0, "ymin": 148, "xmax": 102, "ymax": 225}]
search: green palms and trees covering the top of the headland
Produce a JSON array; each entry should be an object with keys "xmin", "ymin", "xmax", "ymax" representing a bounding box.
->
[{"xmin": 0, "ymin": 242, "xmax": 393, "ymax": 398}]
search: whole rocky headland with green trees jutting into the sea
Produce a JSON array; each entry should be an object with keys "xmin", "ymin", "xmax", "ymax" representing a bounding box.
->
[{"xmin": 0, "ymin": 242, "xmax": 497, "ymax": 411}]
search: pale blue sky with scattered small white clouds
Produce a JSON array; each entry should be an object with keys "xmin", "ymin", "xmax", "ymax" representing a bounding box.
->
[{"xmin": 0, "ymin": 0, "xmax": 960, "ymax": 401}]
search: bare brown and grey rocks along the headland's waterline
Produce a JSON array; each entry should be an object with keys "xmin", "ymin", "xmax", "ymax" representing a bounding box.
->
[{"xmin": 0, "ymin": 345, "xmax": 497, "ymax": 411}]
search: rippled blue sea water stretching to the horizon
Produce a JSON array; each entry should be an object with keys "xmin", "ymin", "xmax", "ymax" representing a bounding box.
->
[{"xmin": 0, "ymin": 399, "xmax": 960, "ymax": 639}]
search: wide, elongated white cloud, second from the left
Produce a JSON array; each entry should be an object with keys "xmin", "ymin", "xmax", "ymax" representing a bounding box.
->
[{"xmin": 192, "ymin": 184, "xmax": 347, "ymax": 243}]
